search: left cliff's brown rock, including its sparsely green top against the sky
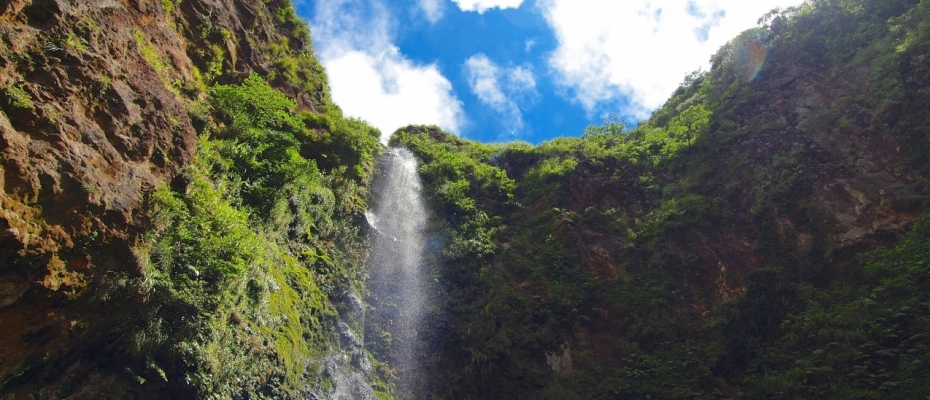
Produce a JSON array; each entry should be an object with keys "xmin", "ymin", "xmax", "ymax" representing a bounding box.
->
[{"xmin": 0, "ymin": 0, "xmax": 338, "ymax": 398}]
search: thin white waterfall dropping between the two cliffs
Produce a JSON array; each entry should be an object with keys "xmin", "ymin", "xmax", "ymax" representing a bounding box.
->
[{"xmin": 365, "ymin": 149, "xmax": 428, "ymax": 399}]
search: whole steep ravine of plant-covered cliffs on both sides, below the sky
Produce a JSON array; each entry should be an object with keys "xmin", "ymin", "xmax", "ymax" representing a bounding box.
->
[{"xmin": 0, "ymin": 0, "xmax": 930, "ymax": 399}]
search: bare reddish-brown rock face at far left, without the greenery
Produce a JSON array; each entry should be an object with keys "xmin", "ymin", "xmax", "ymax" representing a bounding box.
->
[{"xmin": 0, "ymin": 1, "xmax": 196, "ymax": 392}]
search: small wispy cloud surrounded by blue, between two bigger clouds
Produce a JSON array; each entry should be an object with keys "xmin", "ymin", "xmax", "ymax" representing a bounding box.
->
[{"xmin": 464, "ymin": 53, "xmax": 537, "ymax": 132}]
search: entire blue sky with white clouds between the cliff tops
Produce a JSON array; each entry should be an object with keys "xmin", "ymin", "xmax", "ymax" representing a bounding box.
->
[{"xmin": 295, "ymin": 0, "xmax": 801, "ymax": 144}]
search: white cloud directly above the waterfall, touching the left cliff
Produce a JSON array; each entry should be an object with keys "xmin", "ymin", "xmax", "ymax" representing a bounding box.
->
[{"xmin": 311, "ymin": 0, "xmax": 464, "ymax": 141}]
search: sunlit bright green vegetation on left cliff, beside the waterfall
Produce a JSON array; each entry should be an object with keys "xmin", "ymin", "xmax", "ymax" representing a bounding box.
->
[{"xmin": 124, "ymin": 75, "xmax": 380, "ymax": 397}]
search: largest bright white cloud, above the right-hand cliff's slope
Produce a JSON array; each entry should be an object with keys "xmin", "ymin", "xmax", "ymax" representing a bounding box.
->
[{"xmin": 540, "ymin": 0, "xmax": 802, "ymax": 118}]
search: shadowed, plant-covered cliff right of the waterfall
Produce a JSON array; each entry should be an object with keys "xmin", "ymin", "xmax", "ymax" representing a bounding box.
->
[{"xmin": 392, "ymin": 1, "xmax": 930, "ymax": 399}]
